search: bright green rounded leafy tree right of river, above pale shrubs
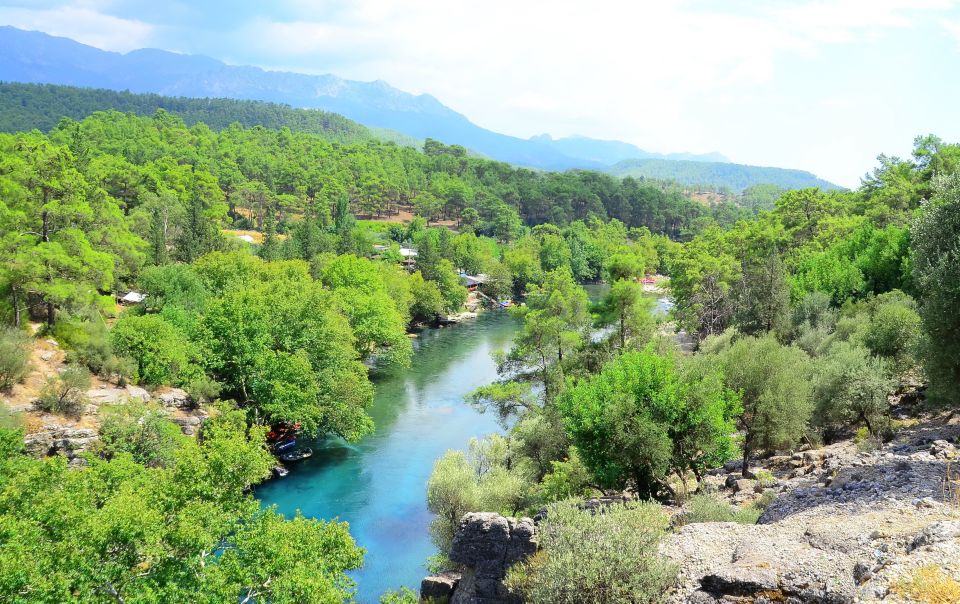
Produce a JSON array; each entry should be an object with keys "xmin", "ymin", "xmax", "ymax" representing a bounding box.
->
[{"xmin": 558, "ymin": 348, "xmax": 737, "ymax": 498}]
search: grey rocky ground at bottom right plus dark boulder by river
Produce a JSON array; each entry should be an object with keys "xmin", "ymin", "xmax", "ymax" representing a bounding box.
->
[{"xmin": 421, "ymin": 416, "xmax": 960, "ymax": 604}]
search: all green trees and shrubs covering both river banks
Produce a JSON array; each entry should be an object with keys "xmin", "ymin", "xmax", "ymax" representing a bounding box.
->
[{"xmin": 0, "ymin": 93, "xmax": 960, "ymax": 603}]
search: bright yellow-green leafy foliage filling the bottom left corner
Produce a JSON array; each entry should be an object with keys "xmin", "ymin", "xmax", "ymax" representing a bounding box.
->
[{"xmin": 0, "ymin": 410, "xmax": 362, "ymax": 603}]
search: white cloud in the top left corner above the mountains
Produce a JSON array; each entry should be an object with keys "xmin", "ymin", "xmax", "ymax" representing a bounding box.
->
[{"xmin": 0, "ymin": 0, "xmax": 154, "ymax": 52}]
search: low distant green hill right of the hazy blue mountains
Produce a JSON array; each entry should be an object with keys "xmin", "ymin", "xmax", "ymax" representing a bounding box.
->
[{"xmin": 607, "ymin": 159, "xmax": 840, "ymax": 192}]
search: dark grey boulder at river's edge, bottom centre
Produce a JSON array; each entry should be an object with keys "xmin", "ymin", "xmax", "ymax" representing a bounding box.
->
[{"xmin": 420, "ymin": 512, "xmax": 537, "ymax": 604}]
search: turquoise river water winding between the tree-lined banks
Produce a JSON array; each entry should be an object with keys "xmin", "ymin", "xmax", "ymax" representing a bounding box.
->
[{"xmin": 257, "ymin": 311, "xmax": 518, "ymax": 604}]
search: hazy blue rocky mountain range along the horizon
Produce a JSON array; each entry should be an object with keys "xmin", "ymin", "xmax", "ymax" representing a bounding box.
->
[{"xmin": 0, "ymin": 26, "xmax": 840, "ymax": 191}]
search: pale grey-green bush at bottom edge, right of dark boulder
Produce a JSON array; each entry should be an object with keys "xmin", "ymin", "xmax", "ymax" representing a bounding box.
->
[{"xmin": 505, "ymin": 502, "xmax": 676, "ymax": 604}]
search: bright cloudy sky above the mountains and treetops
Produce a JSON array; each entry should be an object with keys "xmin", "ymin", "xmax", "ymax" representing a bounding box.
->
[{"xmin": 0, "ymin": 0, "xmax": 960, "ymax": 187}]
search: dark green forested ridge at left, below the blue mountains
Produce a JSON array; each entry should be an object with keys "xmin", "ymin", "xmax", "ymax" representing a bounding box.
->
[{"xmin": 0, "ymin": 82, "xmax": 376, "ymax": 143}]
